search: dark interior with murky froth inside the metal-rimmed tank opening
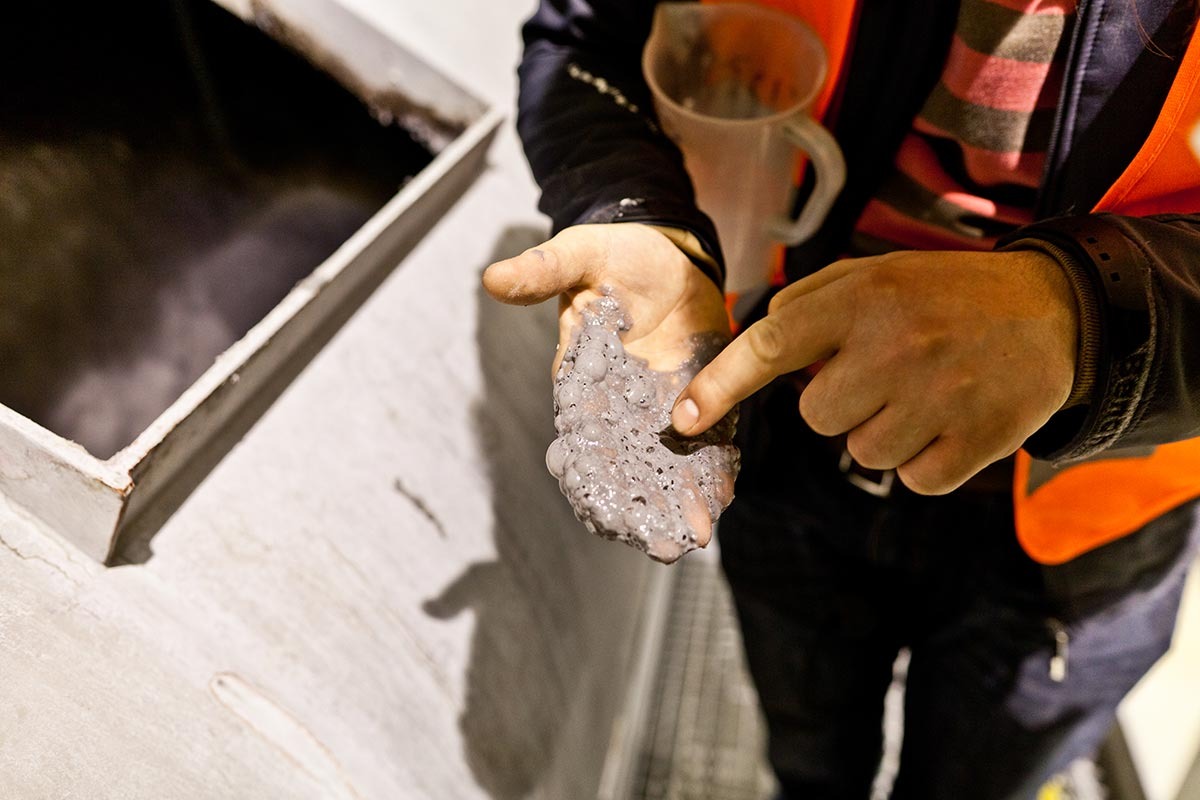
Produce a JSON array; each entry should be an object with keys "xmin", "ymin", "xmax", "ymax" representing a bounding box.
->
[{"xmin": 0, "ymin": 0, "xmax": 432, "ymax": 458}]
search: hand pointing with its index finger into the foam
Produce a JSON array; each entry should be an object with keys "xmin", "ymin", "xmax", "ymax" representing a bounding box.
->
[{"xmin": 672, "ymin": 251, "xmax": 1079, "ymax": 494}]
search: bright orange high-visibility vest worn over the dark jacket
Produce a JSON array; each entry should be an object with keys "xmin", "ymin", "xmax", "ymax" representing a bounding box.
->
[{"xmin": 705, "ymin": 0, "xmax": 1200, "ymax": 564}]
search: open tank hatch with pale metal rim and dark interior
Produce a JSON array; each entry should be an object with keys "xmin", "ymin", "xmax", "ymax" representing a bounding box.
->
[{"xmin": 0, "ymin": 0, "xmax": 500, "ymax": 561}]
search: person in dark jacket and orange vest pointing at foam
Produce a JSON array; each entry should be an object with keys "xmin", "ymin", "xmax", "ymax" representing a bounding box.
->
[{"xmin": 484, "ymin": 0, "xmax": 1200, "ymax": 800}]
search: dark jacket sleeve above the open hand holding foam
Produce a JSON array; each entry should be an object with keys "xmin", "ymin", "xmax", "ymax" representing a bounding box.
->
[{"xmin": 517, "ymin": 0, "xmax": 722, "ymax": 285}]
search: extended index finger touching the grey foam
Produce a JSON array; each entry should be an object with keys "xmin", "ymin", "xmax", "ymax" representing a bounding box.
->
[{"xmin": 671, "ymin": 297, "xmax": 841, "ymax": 437}]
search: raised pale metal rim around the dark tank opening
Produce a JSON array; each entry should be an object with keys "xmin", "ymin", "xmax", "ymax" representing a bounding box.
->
[{"xmin": 0, "ymin": 0, "xmax": 504, "ymax": 563}]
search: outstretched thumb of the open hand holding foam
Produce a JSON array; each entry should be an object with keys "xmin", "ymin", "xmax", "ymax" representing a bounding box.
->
[{"xmin": 484, "ymin": 228, "xmax": 605, "ymax": 306}]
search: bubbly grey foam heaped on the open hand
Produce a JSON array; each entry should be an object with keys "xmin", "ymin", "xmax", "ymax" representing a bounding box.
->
[{"xmin": 546, "ymin": 294, "xmax": 739, "ymax": 563}]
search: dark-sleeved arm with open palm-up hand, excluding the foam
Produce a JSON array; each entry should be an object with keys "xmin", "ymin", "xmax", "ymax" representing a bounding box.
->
[{"xmin": 484, "ymin": 0, "xmax": 728, "ymax": 381}]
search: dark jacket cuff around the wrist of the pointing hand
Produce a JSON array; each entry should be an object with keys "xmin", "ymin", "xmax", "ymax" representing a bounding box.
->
[{"xmin": 997, "ymin": 215, "xmax": 1153, "ymax": 462}]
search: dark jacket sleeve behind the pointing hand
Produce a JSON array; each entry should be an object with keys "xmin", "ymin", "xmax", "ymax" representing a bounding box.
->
[{"xmin": 1001, "ymin": 213, "xmax": 1200, "ymax": 462}]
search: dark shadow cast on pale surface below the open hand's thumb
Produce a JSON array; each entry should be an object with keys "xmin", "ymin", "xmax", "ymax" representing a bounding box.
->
[{"xmin": 424, "ymin": 228, "xmax": 585, "ymax": 800}]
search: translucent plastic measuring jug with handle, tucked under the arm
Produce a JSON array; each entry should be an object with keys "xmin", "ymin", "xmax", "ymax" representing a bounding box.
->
[{"xmin": 642, "ymin": 2, "xmax": 846, "ymax": 317}]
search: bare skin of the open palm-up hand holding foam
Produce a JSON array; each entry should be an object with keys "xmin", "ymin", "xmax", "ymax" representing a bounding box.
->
[{"xmin": 484, "ymin": 222, "xmax": 728, "ymax": 374}]
